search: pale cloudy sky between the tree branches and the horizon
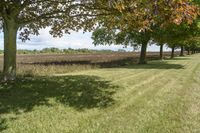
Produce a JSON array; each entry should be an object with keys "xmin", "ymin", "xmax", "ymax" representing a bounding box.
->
[{"xmin": 0, "ymin": 28, "xmax": 170, "ymax": 51}]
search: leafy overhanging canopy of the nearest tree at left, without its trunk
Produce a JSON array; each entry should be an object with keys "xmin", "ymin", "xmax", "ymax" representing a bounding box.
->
[{"xmin": 0, "ymin": 0, "xmax": 101, "ymax": 41}]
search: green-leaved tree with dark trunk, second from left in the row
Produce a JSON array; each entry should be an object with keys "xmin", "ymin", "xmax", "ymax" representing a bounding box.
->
[{"xmin": 92, "ymin": 28, "xmax": 151, "ymax": 64}]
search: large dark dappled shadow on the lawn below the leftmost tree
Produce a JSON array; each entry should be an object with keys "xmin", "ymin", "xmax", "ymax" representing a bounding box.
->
[{"xmin": 0, "ymin": 75, "xmax": 118, "ymax": 131}]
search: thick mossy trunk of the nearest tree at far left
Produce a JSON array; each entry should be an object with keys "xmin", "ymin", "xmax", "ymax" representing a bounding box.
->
[{"xmin": 3, "ymin": 19, "xmax": 18, "ymax": 81}]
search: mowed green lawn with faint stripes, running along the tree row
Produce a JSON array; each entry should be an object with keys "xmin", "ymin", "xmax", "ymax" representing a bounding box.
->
[{"xmin": 0, "ymin": 54, "xmax": 200, "ymax": 133}]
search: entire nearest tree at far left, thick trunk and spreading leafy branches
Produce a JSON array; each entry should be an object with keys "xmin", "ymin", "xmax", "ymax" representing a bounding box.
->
[{"xmin": 0, "ymin": 0, "xmax": 100, "ymax": 81}]
